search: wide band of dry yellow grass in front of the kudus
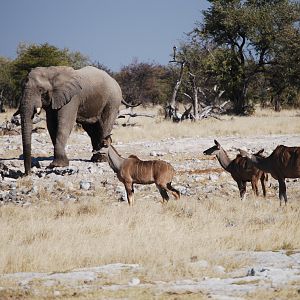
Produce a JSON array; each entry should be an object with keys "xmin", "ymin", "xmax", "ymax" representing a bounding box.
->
[{"xmin": 0, "ymin": 197, "xmax": 300, "ymax": 280}]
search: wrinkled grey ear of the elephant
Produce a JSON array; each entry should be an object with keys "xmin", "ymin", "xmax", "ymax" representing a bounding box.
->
[{"xmin": 51, "ymin": 71, "xmax": 81, "ymax": 109}]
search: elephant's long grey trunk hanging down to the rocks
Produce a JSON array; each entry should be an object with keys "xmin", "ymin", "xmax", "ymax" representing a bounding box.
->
[{"xmin": 21, "ymin": 101, "xmax": 33, "ymax": 175}]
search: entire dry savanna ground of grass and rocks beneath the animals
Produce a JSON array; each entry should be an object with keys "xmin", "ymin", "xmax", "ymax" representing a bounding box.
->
[{"xmin": 0, "ymin": 109, "xmax": 300, "ymax": 299}]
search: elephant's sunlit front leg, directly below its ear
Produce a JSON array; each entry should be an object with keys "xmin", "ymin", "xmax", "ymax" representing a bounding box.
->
[{"xmin": 49, "ymin": 101, "xmax": 77, "ymax": 168}]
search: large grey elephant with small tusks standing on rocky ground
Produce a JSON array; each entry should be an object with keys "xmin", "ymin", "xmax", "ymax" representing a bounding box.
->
[{"xmin": 17, "ymin": 66, "xmax": 132, "ymax": 175}]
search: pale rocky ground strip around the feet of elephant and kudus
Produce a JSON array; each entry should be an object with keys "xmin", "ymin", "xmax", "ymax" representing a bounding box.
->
[{"xmin": 0, "ymin": 130, "xmax": 300, "ymax": 205}]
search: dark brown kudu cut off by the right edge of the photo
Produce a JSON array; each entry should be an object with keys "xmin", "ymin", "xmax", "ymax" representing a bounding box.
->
[{"xmin": 240, "ymin": 145, "xmax": 300, "ymax": 205}]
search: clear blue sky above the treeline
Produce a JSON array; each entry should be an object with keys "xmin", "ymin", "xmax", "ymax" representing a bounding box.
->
[{"xmin": 0, "ymin": 0, "xmax": 209, "ymax": 71}]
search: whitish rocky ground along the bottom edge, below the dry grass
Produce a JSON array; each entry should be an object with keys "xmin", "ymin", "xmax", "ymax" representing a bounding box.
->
[{"xmin": 0, "ymin": 251, "xmax": 300, "ymax": 299}]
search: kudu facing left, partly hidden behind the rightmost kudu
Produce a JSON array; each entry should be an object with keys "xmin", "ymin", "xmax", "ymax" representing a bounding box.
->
[{"xmin": 203, "ymin": 140, "xmax": 268, "ymax": 199}]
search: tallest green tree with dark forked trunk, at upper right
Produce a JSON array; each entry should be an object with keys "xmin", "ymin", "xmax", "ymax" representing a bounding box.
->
[{"xmin": 191, "ymin": 0, "xmax": 300, "ymax": 114}]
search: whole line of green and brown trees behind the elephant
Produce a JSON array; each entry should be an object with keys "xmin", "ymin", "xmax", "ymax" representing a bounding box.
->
[{"xmin": 0, "ymin": 0, "xmax": 300, "ymax": 114}]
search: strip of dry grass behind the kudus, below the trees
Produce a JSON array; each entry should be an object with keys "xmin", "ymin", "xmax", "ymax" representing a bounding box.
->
[{"xmin": 113, "ymin": 109, "xmax": 300, "ymax": 142}]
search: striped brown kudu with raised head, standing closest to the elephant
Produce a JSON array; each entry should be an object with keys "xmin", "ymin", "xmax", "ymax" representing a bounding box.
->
[{"xmin": 101, "ymin": 138, "xmax": 180, "ymax": 206}]
